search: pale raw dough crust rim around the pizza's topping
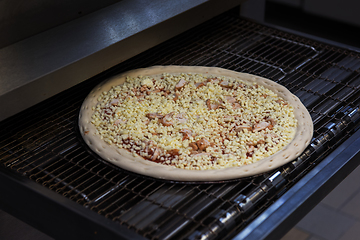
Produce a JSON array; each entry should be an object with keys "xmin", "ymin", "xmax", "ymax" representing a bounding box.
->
[{"xmin": 79, "ymin": 66, "xmax": 313, "ymax": 181}]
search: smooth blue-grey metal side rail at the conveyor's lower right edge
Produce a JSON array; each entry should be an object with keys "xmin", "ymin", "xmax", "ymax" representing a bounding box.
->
[{"xmin": 234, "ymin": 131, "xmax": 360, "ymax": 240}]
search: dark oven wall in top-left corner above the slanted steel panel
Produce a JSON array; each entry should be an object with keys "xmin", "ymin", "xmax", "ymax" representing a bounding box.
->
[{"xmin": 0, "ymin": 0, "xmax": 120, "ymax": 48}]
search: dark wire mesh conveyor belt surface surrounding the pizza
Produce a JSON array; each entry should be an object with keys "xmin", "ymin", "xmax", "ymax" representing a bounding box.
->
[{"xmin": 0, "ymin": 10, "xmax": 360, "ymax": 239}]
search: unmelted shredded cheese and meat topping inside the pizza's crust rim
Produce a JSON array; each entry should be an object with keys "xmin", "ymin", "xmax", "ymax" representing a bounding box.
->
[{"xmin": 91, "ymin": 73, "xmax": 297, "ymax": 170}]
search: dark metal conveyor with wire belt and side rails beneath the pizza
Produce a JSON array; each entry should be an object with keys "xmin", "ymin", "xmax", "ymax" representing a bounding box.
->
[{"xmin": 0, "ymin": 12, "xmax": 360, "ymax": 240}]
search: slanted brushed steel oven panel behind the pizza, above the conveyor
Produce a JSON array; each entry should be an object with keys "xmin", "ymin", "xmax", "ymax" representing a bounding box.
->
[{"xmin": 0, "ymin": 0, "xmax": 241, "ymax": 120}]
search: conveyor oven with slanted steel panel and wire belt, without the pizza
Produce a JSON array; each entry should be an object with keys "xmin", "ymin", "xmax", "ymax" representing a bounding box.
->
[{"xmin": 0, "ymin": 0, "xmax": 360, "ymax": 240}]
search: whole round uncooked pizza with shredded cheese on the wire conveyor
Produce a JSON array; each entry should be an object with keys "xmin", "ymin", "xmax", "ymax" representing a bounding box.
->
[{"xmin": 79, "ymin": 66, "xmax": 313, "ymax": 181}]
